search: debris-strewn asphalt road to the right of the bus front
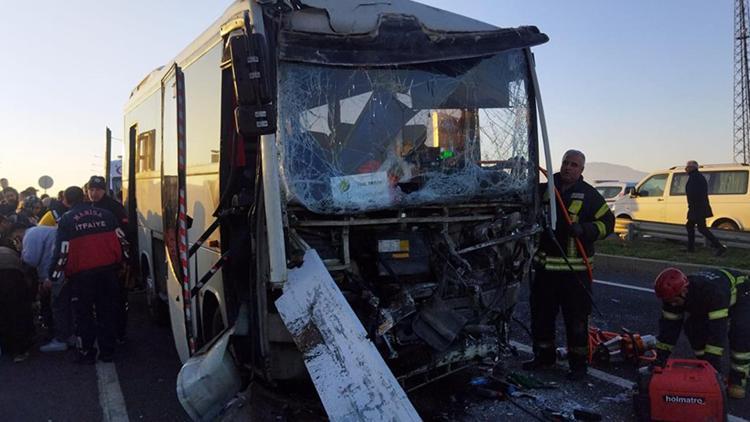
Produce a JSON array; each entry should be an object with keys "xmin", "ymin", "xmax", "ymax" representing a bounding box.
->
[{"xmin": 442, "ymin": 260, "xmax": 750, "ymax": 421}]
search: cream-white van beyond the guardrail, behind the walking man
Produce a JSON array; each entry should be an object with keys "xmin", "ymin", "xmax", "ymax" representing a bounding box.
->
[{"xmin": 615, "ymin": 164, "xmax": 750, "ymax": 231}]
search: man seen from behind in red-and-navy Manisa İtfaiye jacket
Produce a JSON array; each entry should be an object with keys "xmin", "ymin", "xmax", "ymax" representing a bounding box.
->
[{"xmin": 52, "ymin": 186, "xmax": 127, "ymax": 363}]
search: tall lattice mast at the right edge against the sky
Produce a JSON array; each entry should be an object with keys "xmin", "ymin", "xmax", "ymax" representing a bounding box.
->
[{"xmin": 733, "ymin": 0, "xmax": 750, "ymax": 163}]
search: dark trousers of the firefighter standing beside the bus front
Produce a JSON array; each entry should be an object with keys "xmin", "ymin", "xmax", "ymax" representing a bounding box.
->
[{"xmin": 529, "ymin": 269, "xmax": 591, "ymax": 369}]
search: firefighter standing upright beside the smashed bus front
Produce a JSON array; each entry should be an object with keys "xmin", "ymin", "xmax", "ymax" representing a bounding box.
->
[{"xmin": 523, "ymin": 150, "xmax": 615, "ymax": 381}]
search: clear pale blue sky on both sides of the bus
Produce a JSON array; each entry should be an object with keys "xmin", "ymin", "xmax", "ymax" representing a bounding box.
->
[{"xmin": 0, "ymin": 0, "xmax": 734, "ymax": 191}]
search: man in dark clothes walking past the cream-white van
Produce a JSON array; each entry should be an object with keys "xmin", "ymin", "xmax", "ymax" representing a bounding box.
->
[{"xmin": 685, "ymin": 160, "xmax": 727, "ymax": 256}]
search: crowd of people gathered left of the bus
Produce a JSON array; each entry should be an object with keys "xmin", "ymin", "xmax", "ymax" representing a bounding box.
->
[{"xmin": 0, "ymin": 176, "xmax": 129, "ymax": 364}]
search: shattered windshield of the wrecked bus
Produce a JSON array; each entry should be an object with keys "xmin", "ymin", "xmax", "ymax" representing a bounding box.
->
[{"xmin": 277, "ymin": 50, "xmax": 536, "ymax": 214}]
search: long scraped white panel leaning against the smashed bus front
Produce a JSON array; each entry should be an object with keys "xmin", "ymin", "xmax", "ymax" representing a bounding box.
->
[{"xmin": 276, "ymin": 250, "xmax": 421, "ymax": 421}]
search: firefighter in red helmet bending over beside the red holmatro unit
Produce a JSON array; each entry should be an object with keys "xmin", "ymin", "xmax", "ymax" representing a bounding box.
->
[{"xmin": 654, "ymin": 268, "xmax": 750, "ymax": 399}]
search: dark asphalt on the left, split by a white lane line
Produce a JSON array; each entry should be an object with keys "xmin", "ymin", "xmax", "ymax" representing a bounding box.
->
[{"xmin": 0, "ymin": 294, "xmax": 189, "ymax": 422}]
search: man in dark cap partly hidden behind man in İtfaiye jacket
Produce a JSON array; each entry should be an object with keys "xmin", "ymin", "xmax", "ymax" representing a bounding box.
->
[{"xmin": 86, "ymin": 176, "xmax": 130, "ymax": 344}]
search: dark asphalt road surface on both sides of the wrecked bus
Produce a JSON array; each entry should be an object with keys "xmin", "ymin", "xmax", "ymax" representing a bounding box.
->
[{"xmin": 0, "ymin": 261, "xmax": 750, "ymax": 421}]
